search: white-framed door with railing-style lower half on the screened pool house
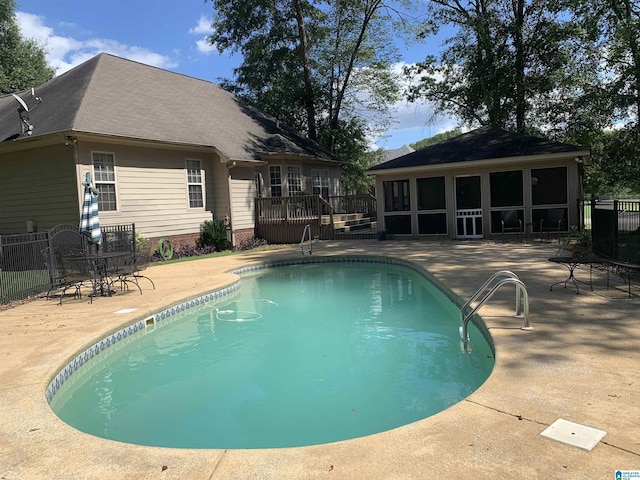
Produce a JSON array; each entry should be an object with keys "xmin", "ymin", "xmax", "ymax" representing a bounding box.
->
[{"xmin": 456, "ymin": 175, "xmax": 483, "ymax": 238}]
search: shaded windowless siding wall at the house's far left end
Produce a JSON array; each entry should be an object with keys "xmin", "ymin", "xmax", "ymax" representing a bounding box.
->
[{"xmin": 0, "ymin": 145, "xmax": 81, "ymax": 234}]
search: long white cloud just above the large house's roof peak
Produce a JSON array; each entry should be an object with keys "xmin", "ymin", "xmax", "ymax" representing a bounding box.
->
[{"xmin": 16, "ymin": 12, "xmax": 177, "ymax": 75}]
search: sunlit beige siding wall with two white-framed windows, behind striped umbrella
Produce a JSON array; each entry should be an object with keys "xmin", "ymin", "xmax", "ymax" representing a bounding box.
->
[{"xmin": 78, "ymin": 144, "xmax": 217, "ymax": 237}]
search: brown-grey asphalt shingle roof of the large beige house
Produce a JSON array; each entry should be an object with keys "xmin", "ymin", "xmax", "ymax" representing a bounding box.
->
[{"xmin": 0, "ymin": 53, "xmax": 339, "ymax": 161}]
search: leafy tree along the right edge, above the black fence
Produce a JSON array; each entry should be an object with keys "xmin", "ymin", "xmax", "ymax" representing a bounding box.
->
[{"xmin": 564, "ymin": 0, "xmax": 640, "ymax": 194}]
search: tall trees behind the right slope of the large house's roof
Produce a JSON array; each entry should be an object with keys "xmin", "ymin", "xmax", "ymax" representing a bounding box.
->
[{"xmin": 209, "ymin": 0, "xmax": 412, "ymax": 161}]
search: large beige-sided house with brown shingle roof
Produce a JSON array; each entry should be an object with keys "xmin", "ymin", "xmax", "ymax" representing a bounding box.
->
[{"xmin": 0, "ymin": 53, "xmax": 342, "ymax": 248}]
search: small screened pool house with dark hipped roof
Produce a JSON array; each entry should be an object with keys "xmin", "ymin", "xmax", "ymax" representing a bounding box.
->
[{"xmin": 367, "ymin": 127, "xmax": 590, "ymax": 239}]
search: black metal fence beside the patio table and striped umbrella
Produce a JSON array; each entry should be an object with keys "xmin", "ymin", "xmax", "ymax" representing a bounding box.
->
[{"xmin": 0, "ymin": 224, "xmax": 136, "ymax": 304}]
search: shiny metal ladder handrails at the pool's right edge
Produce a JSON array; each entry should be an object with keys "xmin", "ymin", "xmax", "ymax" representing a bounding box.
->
[{"xmin": 459, "ymin": 270, "xmax": 533, "ymax": 351}]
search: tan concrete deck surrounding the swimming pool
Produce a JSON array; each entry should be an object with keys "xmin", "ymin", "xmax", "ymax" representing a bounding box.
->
[{"xmin": 0, "ymin": 240, "xmax": 640, "ymax": 480}]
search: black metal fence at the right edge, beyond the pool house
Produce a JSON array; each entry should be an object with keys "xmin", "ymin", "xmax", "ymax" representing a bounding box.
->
[{"xmin": 590, "ymin": 199, "xmax": 640, "ymax": 265}]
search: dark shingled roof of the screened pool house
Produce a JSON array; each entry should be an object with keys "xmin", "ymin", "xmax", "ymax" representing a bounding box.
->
[{"xmin": 369, "ymin": 127, "xmax": 585, "ymax": 171}]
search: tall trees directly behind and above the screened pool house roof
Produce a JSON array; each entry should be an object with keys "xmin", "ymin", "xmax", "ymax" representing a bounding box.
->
[{"xmin": 408, "ymin": 0, "xmax": 581, "ymax": 132}]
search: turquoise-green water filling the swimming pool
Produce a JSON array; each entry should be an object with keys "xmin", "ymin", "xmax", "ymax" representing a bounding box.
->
[{"xmin": 51, "ymin": 263, "xmax": 494, "ymax": 449}]
